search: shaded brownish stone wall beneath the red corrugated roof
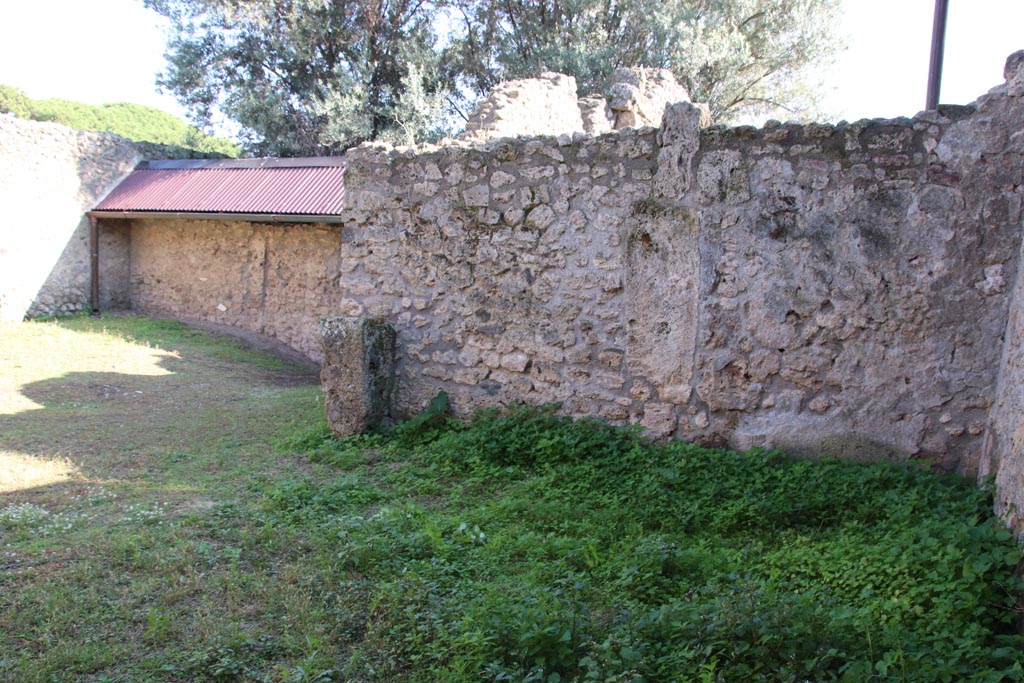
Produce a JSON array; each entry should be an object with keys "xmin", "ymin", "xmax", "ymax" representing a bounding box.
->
[{"xmin": 125, "ymin": 218, "xmax": 342, "ymax": 361}]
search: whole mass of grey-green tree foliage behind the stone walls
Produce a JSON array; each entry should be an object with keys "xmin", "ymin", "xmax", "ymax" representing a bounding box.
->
[{"xmin": 145, "ymin": 0, "xmax": 839, "ymax": 156}]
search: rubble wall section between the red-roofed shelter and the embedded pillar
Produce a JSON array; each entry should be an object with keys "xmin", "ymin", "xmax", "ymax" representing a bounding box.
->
[{"xmin": 339, "ymin": 129, "xmax": 663, "ymax": 422}]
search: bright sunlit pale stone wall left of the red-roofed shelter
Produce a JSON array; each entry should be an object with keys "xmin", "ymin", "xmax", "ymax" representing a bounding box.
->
[{"xmin": 0, "ymin": 115, "xmax": 218, "ymax": 321}]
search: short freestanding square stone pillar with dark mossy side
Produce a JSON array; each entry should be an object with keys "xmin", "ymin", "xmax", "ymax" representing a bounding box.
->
[{"xmin": 318, "ymin": 316, "xmax": 395, "ymax": 436}]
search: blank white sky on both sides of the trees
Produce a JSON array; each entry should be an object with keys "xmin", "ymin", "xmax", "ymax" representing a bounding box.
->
[{"xmin": 0, "ymin": 0, "xmax": 1024, "ymax": 127}]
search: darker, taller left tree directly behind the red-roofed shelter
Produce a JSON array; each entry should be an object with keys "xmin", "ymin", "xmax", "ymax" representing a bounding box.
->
[{"xmin": 145, "ymin": 0, "xmax": 450, "ymax": 156}]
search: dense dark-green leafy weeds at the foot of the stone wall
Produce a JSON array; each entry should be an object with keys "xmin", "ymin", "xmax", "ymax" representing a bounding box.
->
[{"xmin": 267, "ymin": 407, "xmax": 1024, "ymax": 683}]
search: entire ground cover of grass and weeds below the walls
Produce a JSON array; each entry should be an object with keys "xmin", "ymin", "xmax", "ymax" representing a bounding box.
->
[{"xmin": 0, "ymin": 318, "xmax": 1024, "ymax": 683}]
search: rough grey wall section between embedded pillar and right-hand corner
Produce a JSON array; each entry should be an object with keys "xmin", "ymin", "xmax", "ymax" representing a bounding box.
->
[{"xmin": 681, "ymin": 110, "xmax": 1020, "ymax": 472}]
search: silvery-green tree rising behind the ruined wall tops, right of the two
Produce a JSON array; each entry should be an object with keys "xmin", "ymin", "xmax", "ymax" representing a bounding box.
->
[{"xmin": 452, "ymin": 0, "xmax": 840, "ymax": 121}]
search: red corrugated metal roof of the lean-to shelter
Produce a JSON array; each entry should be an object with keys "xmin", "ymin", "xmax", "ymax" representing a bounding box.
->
[{"xmin": 93, "ymin": 158, "xmax": 345, "ymax": 216}]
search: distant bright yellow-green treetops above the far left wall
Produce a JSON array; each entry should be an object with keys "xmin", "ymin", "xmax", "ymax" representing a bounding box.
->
[{"xmin": 0, "ymin": 85, "xmax": 241, "ymax": 157}]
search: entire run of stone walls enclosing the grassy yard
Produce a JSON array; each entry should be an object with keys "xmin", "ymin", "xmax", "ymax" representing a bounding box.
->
[{"xmin": 6, "ymin": 60, "xmax": 1024, "ymax": 529}]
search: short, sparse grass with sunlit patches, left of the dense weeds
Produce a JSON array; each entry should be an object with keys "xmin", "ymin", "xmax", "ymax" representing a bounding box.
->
[{"xmin": 0, "ymin": 317, "xmax": 335, "ymax": 683}]
